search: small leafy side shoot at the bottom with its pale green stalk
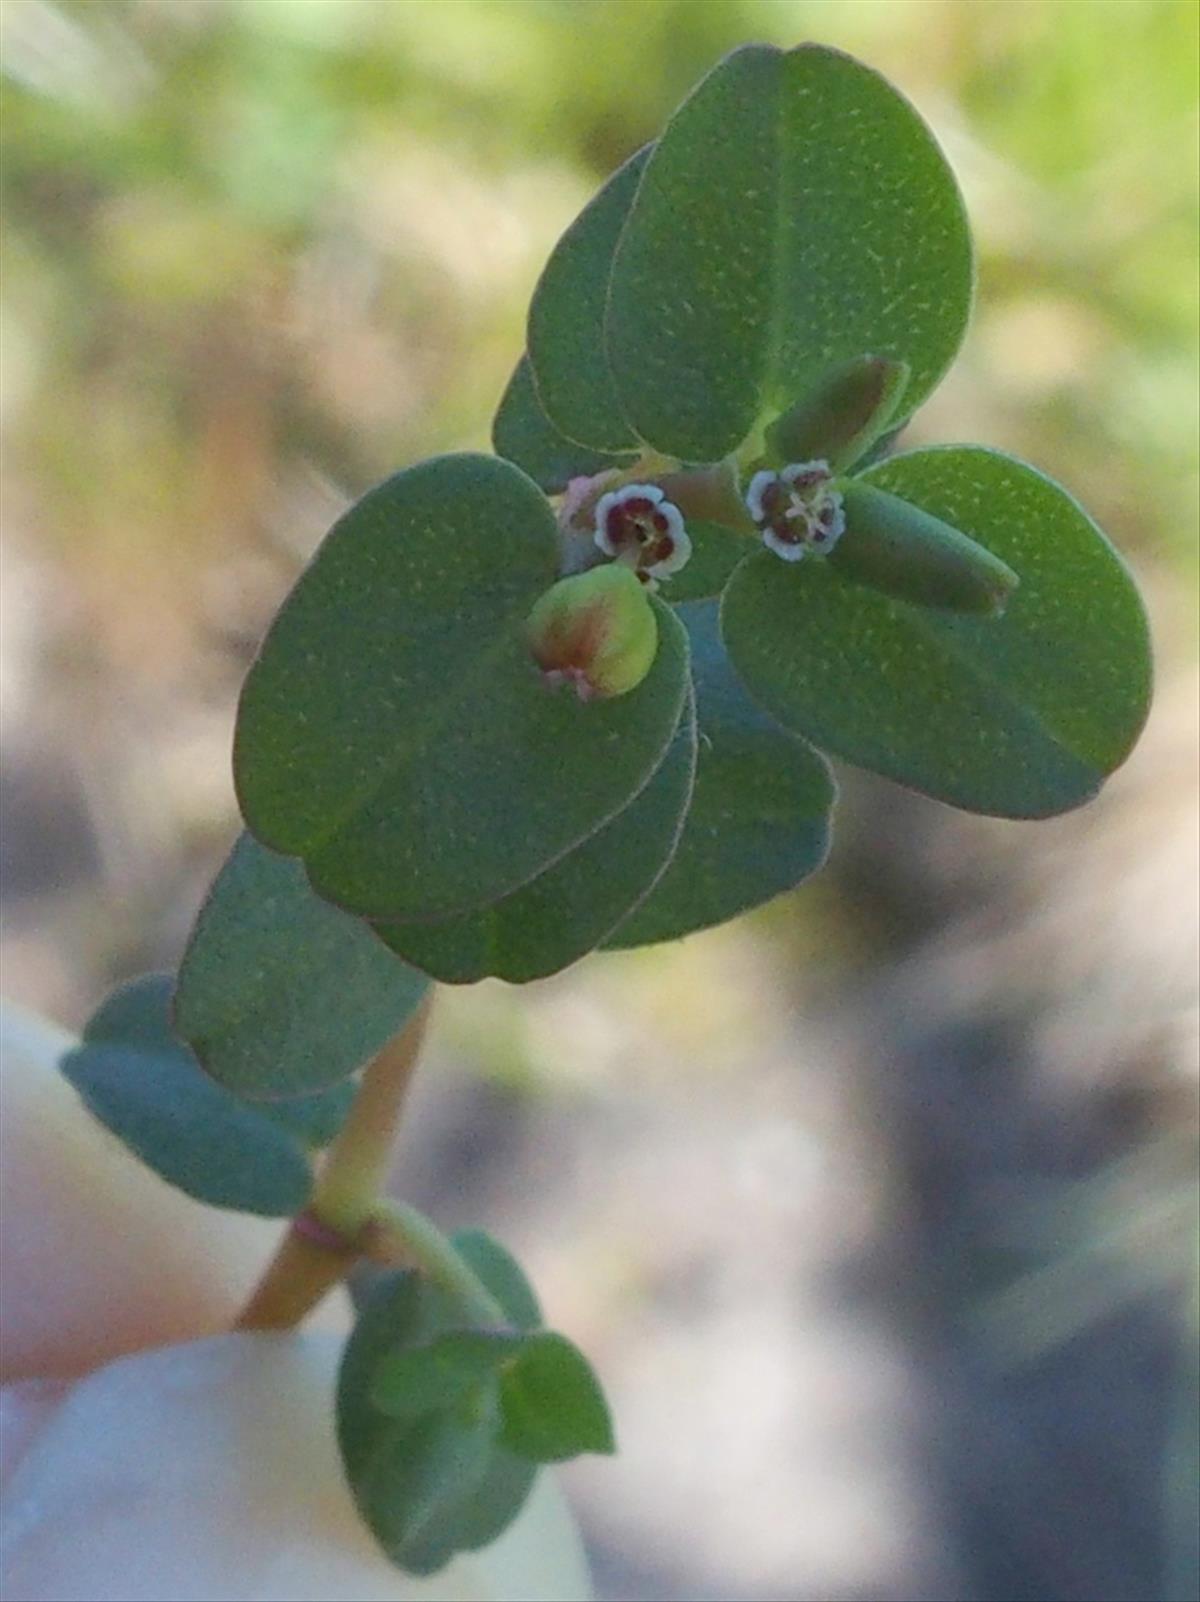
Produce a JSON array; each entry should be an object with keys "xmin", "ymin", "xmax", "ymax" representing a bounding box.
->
[{"xmin": 338, "ymin": 1232, "xmax": 614, "ymax": 1573}]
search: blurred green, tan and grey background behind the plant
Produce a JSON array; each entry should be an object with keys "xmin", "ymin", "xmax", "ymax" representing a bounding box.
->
[{"xmin": 0, "ymin": 0, "xmax": 1200, "ymax": 1602}]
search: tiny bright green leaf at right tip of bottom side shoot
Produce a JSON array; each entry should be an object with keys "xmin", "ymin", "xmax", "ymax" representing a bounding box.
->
[{"xmin": 500, "ymin": 1330, "xmax": 617, "ymax": 1463}]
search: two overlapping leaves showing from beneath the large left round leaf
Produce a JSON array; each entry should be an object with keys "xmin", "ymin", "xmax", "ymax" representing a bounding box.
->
[{"xmin": 378, "ymin": 602, "xmax": 835, "ymax": 984}]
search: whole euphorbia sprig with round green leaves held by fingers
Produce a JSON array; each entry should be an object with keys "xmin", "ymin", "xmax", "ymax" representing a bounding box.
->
[{"xmin": 51, "ymin": 45, "xmax": 1150, "ymax": 1572}]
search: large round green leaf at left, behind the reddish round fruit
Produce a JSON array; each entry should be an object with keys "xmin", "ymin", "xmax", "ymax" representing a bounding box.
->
[{"xmin": 234, "ymin": 455, "xmax": 687, "ymax": 921}]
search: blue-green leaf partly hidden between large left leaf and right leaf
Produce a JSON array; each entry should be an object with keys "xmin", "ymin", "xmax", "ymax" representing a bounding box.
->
[{"xmin": 606, "ymin": 602, "xmax": 835, "ymax": 950}]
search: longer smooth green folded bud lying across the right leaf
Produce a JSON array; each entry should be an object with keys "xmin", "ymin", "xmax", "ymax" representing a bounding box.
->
[{"xmin": 828, "ymin": 479, "xmax": 1021, "ymax": 614}]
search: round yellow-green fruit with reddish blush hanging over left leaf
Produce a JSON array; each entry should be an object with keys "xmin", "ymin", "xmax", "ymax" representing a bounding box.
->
[{"xmin": 529, "ymin": 562, "xmax": 658, "ymax": 700}]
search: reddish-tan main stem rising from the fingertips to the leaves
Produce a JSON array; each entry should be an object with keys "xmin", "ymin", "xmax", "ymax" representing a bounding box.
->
[{"xmin": 234, "ymin": 990, "xmax": 433, "ymax": 1330}]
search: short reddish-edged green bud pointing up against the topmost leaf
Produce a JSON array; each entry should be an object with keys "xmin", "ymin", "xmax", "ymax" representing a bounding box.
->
[{"xmin": 766, "ymin": 356, "xmax": 908, "ymax": 474}]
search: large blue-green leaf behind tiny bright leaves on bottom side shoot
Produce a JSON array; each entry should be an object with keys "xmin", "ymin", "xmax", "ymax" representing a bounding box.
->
[{"xmin": 336, "ymin": 1272, "xmax": 535, "ymax": 1573}]
